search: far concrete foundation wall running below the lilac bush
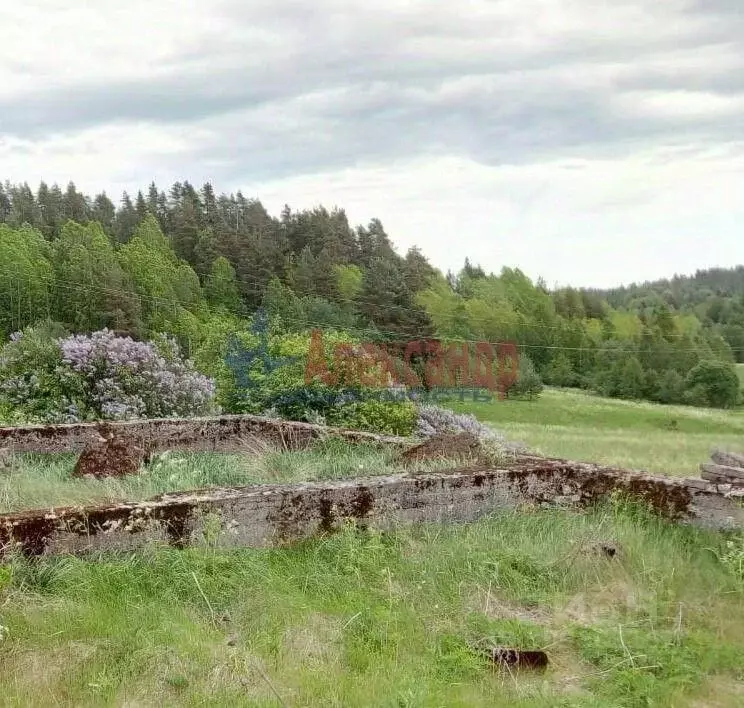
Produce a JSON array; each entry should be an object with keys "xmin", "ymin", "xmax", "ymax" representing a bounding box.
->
[{"xmin": 0, "ymin": 415, "xmax": 410, "ymax": 453}]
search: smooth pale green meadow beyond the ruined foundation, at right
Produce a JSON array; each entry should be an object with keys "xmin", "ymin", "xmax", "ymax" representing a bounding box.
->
[{"xmin": 452, "ymin": 389, "xmax": 744, "ymax": 476}]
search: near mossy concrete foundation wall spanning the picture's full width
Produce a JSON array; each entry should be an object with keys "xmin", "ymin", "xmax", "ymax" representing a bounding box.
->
[{"xmin": 0, "ymin": 460, "xmax": 744, "ymax": 556}]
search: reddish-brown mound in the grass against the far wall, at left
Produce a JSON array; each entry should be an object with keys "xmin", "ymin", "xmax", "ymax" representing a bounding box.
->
[{"xmin": 72, "ymin": 427, "xmax": 148, "ymax": 479}]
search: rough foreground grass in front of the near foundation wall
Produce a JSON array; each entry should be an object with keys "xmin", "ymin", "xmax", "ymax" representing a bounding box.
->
[{"xmin": 0, "ymin": 505, "xmax": 744, "ymax": 708}]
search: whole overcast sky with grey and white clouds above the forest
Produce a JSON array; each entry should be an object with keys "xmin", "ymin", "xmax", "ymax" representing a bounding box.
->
[{"xmin": 0, "ymin": 0, "xmax": 744, "ymax": 286}]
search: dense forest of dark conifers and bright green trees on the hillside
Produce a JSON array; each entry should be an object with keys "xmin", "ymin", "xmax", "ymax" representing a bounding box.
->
[{"xmin": 0, "ymin": 182, "xmax": 744, "ymax": 406}]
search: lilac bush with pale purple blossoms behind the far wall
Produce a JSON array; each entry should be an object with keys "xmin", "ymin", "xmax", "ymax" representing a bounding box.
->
[{"xmin": 0, "ymin": 329, "xmax": 215, "ymax": 422}]
